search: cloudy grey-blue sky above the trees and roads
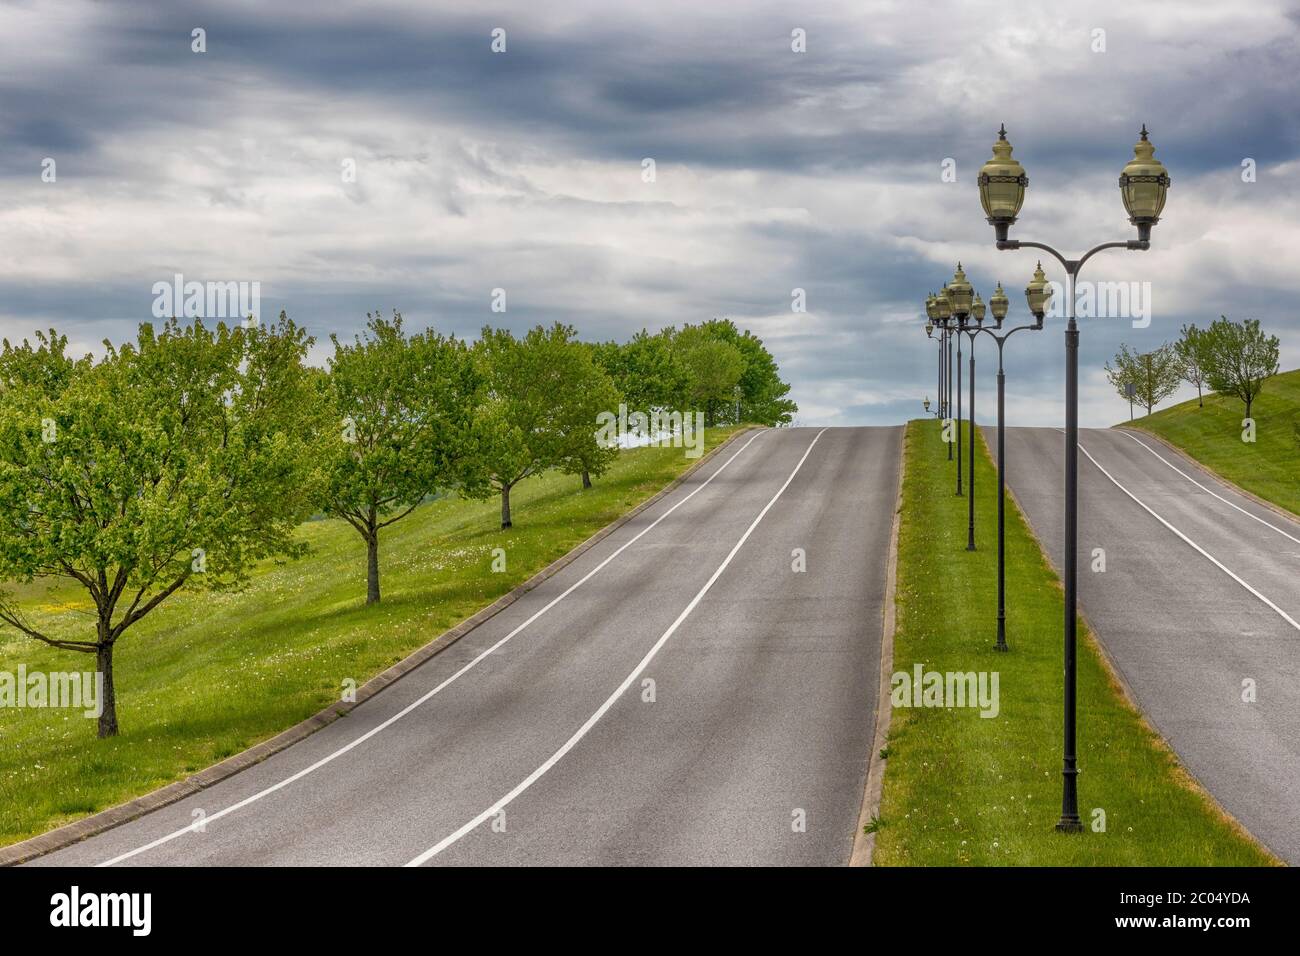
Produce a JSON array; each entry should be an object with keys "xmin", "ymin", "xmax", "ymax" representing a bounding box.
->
[{"xmin": 0, "ymin": 0, "xmax": 1300, "ymax": 425}]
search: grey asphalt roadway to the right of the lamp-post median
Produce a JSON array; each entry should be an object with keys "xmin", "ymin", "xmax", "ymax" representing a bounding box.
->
[{"xmin": 985, "ymin": 428, "xmax": 1300, "ymax": 864}]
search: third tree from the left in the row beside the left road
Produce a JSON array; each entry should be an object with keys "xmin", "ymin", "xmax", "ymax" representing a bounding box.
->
[{"xmin": 473, "ymin": 323, "xmax": 582, "ymax": 528}]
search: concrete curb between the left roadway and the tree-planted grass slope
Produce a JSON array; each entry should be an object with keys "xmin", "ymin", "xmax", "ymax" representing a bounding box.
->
[{"xmin": 0, "ymin": 425, "xmax": 758, "ymax": 866}]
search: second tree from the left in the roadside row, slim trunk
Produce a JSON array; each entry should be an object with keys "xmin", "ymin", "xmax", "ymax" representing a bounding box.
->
[{"xmin": 325, "ymin": 312, "xmax": 481, "ymax": 605}]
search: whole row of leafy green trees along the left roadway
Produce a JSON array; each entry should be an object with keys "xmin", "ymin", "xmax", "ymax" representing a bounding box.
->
[{"xmin": 0, "ymin": 312, "xmax": 796, "ymax": 737}]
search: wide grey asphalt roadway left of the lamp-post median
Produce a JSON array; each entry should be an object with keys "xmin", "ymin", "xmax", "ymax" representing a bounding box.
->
[{"xmin": 35, "ymin": 428, "xmax": 902, "ymax": 866}]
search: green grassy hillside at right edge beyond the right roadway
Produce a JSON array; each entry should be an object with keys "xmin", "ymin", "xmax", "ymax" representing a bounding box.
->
[{"xmin": 1122, "ymin": 369, "xmax": 1300, "ymax": 515}]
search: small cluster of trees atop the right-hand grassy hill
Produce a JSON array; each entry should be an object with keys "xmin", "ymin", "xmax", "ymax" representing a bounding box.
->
[{"xmin": 1106, "ymin": 316, "xmax": 1281, "ymax": 418}]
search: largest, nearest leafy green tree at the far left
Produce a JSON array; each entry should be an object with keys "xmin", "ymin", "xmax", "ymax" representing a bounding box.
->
[{"xmin": 0, "ymin": 313, "xmax": 320, "ymax": 737}]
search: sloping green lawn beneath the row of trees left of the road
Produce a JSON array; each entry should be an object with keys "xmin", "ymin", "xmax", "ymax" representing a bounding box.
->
[{"xmin": 0, "ymin": 429, "xmax": 735, "ymax": 844}]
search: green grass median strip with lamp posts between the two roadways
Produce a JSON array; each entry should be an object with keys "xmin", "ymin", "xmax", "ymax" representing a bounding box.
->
[{"xmin": 875, "ymin": 420, "xmax": 1275, "ymax": 866}]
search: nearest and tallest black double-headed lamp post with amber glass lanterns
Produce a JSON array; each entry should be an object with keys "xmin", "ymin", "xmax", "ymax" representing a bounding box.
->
[{"xmin": 979, "ymin": 125, "xmax": 1169, "ymax": 832}]
